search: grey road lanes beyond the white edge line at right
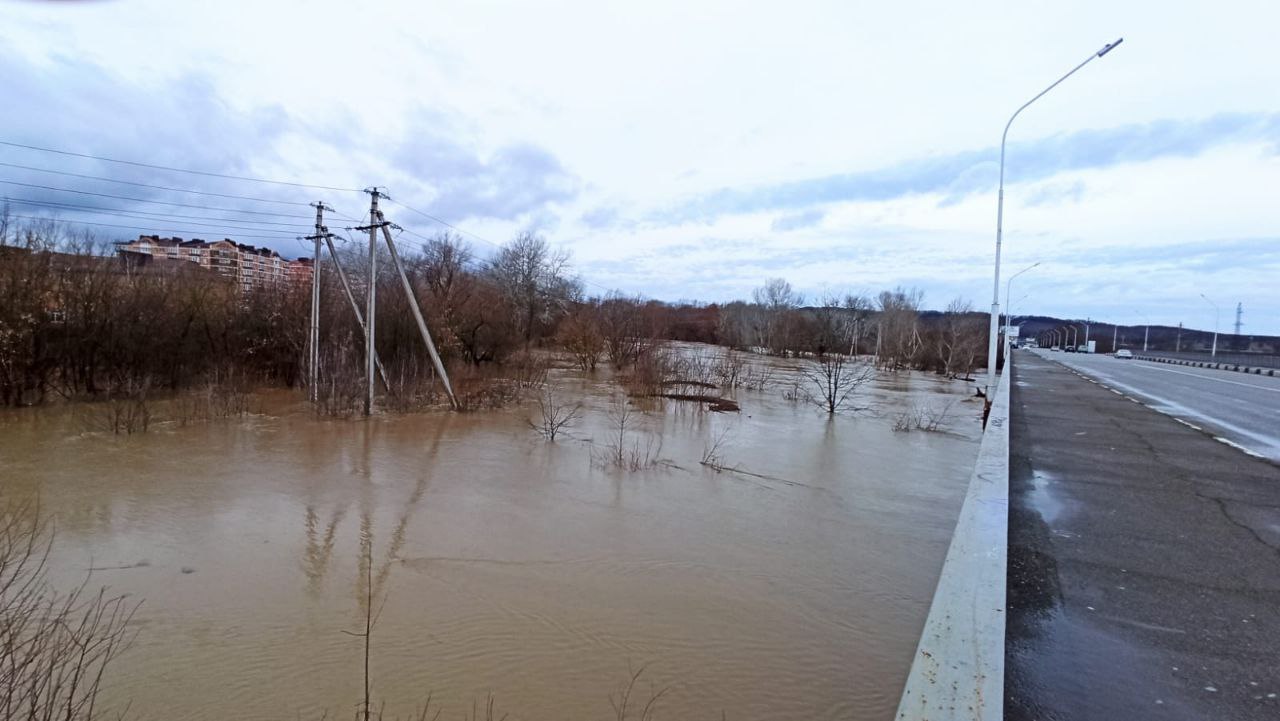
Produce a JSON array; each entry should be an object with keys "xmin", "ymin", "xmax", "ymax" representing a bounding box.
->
[{"xmin": 1034, "ymin": 350, "xmax": 1280, "ymax": 461}]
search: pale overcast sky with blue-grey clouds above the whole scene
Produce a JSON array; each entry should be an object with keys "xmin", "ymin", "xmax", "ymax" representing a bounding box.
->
[{"xmin": 0, "ymin": 0, "xmax": 1280, "ymax": 334}]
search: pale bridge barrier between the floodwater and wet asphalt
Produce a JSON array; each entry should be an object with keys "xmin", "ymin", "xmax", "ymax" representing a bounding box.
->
[{"xmin": 895, "ymin": 370, "xmax": 1009, "ymax": 721}]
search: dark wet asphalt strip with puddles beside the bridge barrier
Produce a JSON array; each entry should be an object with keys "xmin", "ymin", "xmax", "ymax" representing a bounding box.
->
[{"xmin": 1005, "ymin": 351, "xmax": 1280, "ymax": 721}]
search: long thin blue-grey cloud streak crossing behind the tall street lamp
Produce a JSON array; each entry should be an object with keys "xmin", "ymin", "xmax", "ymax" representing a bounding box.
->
[{"xmin": 654, "ymin": 113, "xmax": 1280, "ymax": 223}]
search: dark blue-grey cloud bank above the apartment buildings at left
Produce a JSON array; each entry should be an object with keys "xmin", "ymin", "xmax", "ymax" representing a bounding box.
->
[{"xmin": 0, "ymin": 46, "xmax": 330, "ymax": 250}]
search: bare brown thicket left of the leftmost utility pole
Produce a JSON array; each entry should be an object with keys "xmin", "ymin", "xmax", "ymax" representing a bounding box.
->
[{"xmin": 0, "ymin": 222, "xmax": 306, "ymax": 406}]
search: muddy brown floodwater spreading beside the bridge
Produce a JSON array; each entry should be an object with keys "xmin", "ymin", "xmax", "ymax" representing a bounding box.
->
[{"xmin": 0, "ymin": 348, "xmax": 980, "ymax": 720}]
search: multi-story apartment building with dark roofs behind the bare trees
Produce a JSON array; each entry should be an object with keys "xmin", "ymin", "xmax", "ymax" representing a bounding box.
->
[{"xmin": 116, "ymin": 236, "xmax": 304, "ymax": 292}]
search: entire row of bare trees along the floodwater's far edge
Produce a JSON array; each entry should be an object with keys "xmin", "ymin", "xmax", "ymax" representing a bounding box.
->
[{"xmin": 0, "ymin": 213, "xmax": 987, "ymax": 406}]
